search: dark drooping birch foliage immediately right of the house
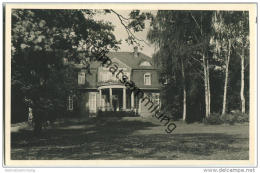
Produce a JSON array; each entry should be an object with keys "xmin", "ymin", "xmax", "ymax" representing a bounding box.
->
[{"xmin": 145, "ymin": 10, "xmax": 212, "ymax": 122}]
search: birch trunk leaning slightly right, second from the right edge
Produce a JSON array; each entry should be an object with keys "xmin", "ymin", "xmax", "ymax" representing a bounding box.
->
[{"xmin": 222, "ymin": 40, "xmax": 231, "ymax": 115}]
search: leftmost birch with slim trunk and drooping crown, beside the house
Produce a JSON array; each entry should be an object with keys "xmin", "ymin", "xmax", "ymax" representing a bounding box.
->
[{"xmin": 148, "ymin": 11, "xmax": 193, "ymax": 121}]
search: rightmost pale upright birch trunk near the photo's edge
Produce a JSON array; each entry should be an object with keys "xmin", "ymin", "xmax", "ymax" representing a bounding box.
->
[{"xmin": 240, "ymin": 48, "xmax": 246, "ymax": 113}]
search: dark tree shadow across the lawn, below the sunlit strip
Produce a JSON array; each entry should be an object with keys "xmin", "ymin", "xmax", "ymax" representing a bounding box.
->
[{"xmin": 11, "ymin": 118, "xmax": 248, "ymax": 160}]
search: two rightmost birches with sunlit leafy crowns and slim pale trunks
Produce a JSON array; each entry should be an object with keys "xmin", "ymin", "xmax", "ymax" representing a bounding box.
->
[{"xmin": 214, "ymin": 11, "xmax": 248, "ymax": 114}]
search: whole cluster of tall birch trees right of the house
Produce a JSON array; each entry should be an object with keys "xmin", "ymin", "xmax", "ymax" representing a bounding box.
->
[{"xmin": 130, "ymin": 10, "xmax": 249, "ymax": 119}]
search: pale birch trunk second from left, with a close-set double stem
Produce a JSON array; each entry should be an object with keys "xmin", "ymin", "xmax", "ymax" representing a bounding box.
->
[{"xmin": 202, "ymin": 53, "xmax": 210, "ymax": 118}]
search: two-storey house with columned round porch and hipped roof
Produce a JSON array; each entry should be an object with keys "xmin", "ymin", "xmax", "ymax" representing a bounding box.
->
[{"xmin": 68, "ymin": 47, "xmax": 160, "ymax": 116}]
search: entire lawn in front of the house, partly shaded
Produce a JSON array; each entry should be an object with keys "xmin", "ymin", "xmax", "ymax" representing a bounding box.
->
[{"xmin": 11, "ymin": 117, "xmax": 249, "ymax": 160}]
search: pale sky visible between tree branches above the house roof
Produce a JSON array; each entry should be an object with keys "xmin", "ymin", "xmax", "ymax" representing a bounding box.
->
[{"xmin": 94, "ymin": 10, "xmax": 156, "ymax": 57}]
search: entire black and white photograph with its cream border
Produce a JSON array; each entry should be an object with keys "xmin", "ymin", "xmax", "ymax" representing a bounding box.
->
[{"xmin": 4, "ymin": 3, "xmax": 257, "ymax": 166}]
